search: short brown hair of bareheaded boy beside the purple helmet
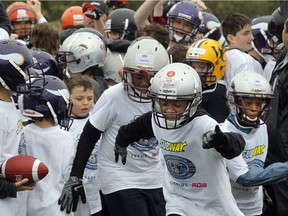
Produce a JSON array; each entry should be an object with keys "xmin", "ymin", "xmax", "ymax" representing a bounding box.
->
[{"xmin": 64, "ymin": 75, "xmax": 93, "ymax": 94}]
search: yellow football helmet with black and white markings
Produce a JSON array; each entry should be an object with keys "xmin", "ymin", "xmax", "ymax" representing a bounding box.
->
[{"xmin": 183, "ymin": 39, "xmax": 227, "ymax": 88}]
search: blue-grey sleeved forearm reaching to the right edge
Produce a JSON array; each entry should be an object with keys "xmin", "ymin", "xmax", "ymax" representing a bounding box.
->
[{"xmin": 236, "ymin": 162, "xmax": 288, "ymax": 187}]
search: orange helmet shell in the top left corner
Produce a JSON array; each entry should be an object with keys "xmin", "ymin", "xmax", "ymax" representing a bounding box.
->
[{"xmin": 6, "ymin": 2, "xmax": 36, "ymax": 23}]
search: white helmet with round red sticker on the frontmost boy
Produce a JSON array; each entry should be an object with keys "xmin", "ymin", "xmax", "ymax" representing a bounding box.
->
[{"xmin": 149, "ymin": 63, "xmax": 202, "ymax": 129}]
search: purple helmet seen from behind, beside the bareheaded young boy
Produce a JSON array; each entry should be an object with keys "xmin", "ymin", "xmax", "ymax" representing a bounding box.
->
[{"xmin": 18, "ymin": 75, "xmax": 72, "ymax": 130}]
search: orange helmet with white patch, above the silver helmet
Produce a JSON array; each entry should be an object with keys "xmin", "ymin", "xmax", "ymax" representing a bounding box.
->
[{"xmin": 61, "ymin": 6, "xmax": 84, "ymax": 29}]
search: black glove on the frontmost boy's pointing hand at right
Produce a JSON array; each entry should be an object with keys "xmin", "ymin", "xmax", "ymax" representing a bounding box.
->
[{"xmin": 202, "ymin": 125, "xmax": 225, "ymax": 149}]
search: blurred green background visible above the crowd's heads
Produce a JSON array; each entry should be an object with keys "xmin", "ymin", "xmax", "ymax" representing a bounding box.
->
[{"xmin": 3, "ymin": 0, "xmax": 279, "ymax": 30}]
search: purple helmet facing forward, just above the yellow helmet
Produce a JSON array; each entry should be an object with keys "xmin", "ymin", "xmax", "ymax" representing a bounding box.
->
[{"xmin": 167, "ymin": 1, "xmax": 202, "ymax": 44}]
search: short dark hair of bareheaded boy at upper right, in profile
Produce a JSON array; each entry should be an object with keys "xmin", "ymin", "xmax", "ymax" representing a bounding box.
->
[{"xmin": 221, "ymin": 12, "xmax": 252, "ymax": 41}]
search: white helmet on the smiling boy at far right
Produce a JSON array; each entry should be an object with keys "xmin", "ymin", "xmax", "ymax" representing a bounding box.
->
[{"xmin": 227, "ymin": 71, "xmax": 274, "ymax": 127}]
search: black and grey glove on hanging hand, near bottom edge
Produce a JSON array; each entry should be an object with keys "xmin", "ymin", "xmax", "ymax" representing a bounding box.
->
[{"xmin": 58, "ymin": 176, "xmax": 86, "ymax": 214}]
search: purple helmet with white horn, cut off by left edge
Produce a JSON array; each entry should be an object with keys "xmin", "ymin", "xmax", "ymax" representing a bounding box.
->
[{"xmin": 0, "ymin": 40, "xmax": 35, "ymax": 93}]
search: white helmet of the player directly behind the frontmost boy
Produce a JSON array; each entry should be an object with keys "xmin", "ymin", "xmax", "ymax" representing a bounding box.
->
[{"xmin": 123, "ymin": 37, "xmax": 169, "ymax": 103}]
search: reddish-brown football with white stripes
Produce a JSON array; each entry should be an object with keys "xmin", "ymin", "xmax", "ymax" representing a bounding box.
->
[{"xmin": 0, "ymin": 155, "xmax": 49, "ymax": 184}]
